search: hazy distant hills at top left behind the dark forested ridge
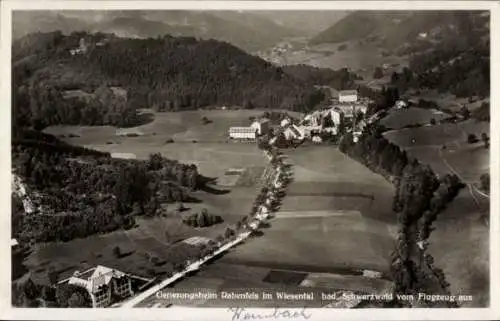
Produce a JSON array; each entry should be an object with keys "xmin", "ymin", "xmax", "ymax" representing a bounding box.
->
[{"xmin": 13, "ymin": 11, "xmax": 295, "ymax": 51}]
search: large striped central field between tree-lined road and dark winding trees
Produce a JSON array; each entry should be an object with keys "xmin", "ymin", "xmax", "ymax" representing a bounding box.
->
[{"xmin": 152, "ymin": 146, "xmax": 396, "ymax": 306}]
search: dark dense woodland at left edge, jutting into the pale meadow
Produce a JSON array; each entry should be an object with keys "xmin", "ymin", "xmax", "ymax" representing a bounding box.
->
[{"xmin": 12, "ymin": 134, "xmax": 201, "ymax": 241}]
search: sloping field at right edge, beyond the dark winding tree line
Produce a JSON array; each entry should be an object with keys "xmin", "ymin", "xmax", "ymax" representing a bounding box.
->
[{"xmin": 385, "ymin": 120, "xmax": 490, "ymax": 307}]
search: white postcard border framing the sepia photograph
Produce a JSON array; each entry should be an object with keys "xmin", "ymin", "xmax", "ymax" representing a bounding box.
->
[{"xmin": 0, "ymin": 0, "xmax": 500, "ymax": 320}]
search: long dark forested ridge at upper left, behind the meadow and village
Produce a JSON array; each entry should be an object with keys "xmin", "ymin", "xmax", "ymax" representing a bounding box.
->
[{"xmin": 12, "ymin": 32, "xmax": 343, "ymax": 128}]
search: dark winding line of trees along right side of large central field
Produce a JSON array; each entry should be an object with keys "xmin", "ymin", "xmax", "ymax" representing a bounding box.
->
[{"xmin": 339, "ymin": 125, "xmax": 464, "ymax": 304}]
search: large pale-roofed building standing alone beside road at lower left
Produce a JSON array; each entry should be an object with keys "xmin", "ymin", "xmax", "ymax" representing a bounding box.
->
[{"xmin": 59, "ymin": 265, "xmax": 133, "ymax": 308}]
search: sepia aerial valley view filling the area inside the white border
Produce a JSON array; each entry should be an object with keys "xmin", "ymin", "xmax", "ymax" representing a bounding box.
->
[{"xmin": 10, "ymin": 8, "xmax": 491, "ymax": 308}]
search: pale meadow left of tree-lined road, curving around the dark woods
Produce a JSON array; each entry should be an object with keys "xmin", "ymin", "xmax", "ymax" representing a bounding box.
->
[{"xmin": 24, "ymin": 111, "xmax": 282, "ymax": 280}]
